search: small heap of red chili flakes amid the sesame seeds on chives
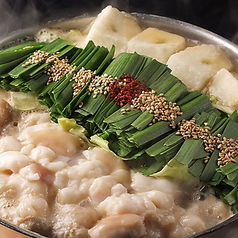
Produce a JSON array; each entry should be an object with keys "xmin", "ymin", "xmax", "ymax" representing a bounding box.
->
[{"xmin": 109, "ymin": 74, "xmax": 150, "ymax": 107}]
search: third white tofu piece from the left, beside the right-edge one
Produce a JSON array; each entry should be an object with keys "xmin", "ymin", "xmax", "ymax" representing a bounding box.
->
[{"xmin": 167, "ymin": 45, "xmax": 232, "ymax": 91}]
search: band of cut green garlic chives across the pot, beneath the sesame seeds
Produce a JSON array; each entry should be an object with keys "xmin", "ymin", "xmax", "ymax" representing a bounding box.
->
[{"xmin": 0, "ymin": 38, "xmax": 238, "ymax": 210}]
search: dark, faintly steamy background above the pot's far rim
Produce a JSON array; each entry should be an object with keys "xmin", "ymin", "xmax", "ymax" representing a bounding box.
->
[{"xmin": 0, "ymin": 0, "xmax": 238, "ymax": 44}]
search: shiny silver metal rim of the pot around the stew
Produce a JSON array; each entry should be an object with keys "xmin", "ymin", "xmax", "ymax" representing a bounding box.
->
[{"xmin": 0, "ymin": 12, "xmax": 238, "ymax": 238}]
